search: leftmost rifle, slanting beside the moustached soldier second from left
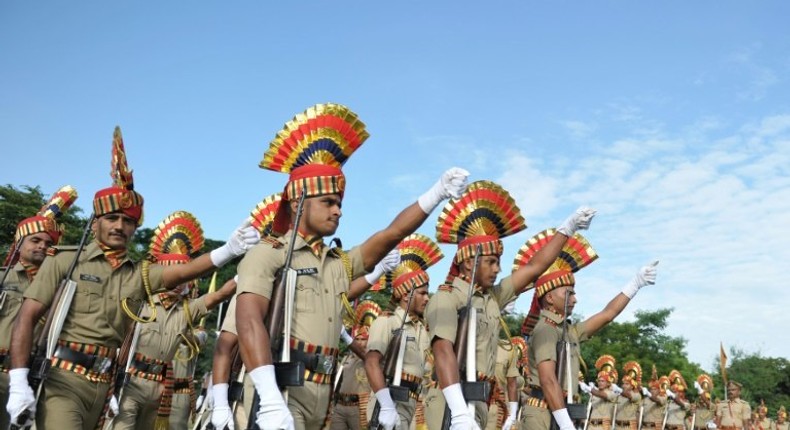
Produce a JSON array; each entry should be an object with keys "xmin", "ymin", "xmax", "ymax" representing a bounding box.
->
[{"xmin": 10, "ymin": 214, "xmax": 94, "ymax": 430}]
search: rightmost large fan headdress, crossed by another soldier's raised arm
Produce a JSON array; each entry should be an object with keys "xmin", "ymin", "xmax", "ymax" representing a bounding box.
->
[{"xmin": 513, "ymin": 228, "xmax": 598, "ymax": 336}]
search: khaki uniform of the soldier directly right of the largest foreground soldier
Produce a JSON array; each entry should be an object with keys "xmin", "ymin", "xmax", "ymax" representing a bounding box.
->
[{"xmin": 425, "ymin": 276, "xmax": 515, "ymax": 429}]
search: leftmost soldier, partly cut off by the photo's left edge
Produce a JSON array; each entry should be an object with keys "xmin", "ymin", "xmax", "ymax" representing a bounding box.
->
[{"xmin": 0, "ymin": 185, "xmax": 77, "ymax": 429}]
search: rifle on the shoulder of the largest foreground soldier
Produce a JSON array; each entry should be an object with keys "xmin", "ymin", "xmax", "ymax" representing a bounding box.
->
[{"xmin": 247, "ymin": 192, "xmax": 307, "ymax": 430}]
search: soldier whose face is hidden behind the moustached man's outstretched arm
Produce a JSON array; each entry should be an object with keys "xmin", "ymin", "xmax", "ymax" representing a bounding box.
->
[{"xmin": 113, "ymin": 211, "xmax": 236, "ymax": 430}]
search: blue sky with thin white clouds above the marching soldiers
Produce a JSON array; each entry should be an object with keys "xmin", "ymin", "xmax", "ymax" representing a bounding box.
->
[{"xmin": 0, "ymin": 1, "xmax": 790, "ymax": 368}]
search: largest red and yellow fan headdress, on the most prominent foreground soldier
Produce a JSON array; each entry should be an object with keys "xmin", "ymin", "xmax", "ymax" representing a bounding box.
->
[{"xmin": 259, "ymin": 103, "xmax": 370, "ymax": 234}]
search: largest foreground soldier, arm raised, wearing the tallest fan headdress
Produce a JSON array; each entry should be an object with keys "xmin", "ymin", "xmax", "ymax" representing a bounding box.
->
[{"xmin": 236, "ymin": 104, "xmax": 468, "ymax": 429}]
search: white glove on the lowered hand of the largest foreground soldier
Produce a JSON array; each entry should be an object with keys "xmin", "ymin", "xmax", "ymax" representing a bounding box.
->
[{"xmin": 250, "ymin": 364, "xmax": 294, "ymax": 430}]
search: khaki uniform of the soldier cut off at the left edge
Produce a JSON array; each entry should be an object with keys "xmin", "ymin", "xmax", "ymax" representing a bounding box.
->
[{"xmin": 0, "ymin": 263, "xmax": 32, "ymax": 429}]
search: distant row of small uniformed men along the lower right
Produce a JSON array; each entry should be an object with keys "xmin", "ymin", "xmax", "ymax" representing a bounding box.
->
[{"xmin": 579, "ymin": 355, "xmax": 788, "ymax": 430}]
